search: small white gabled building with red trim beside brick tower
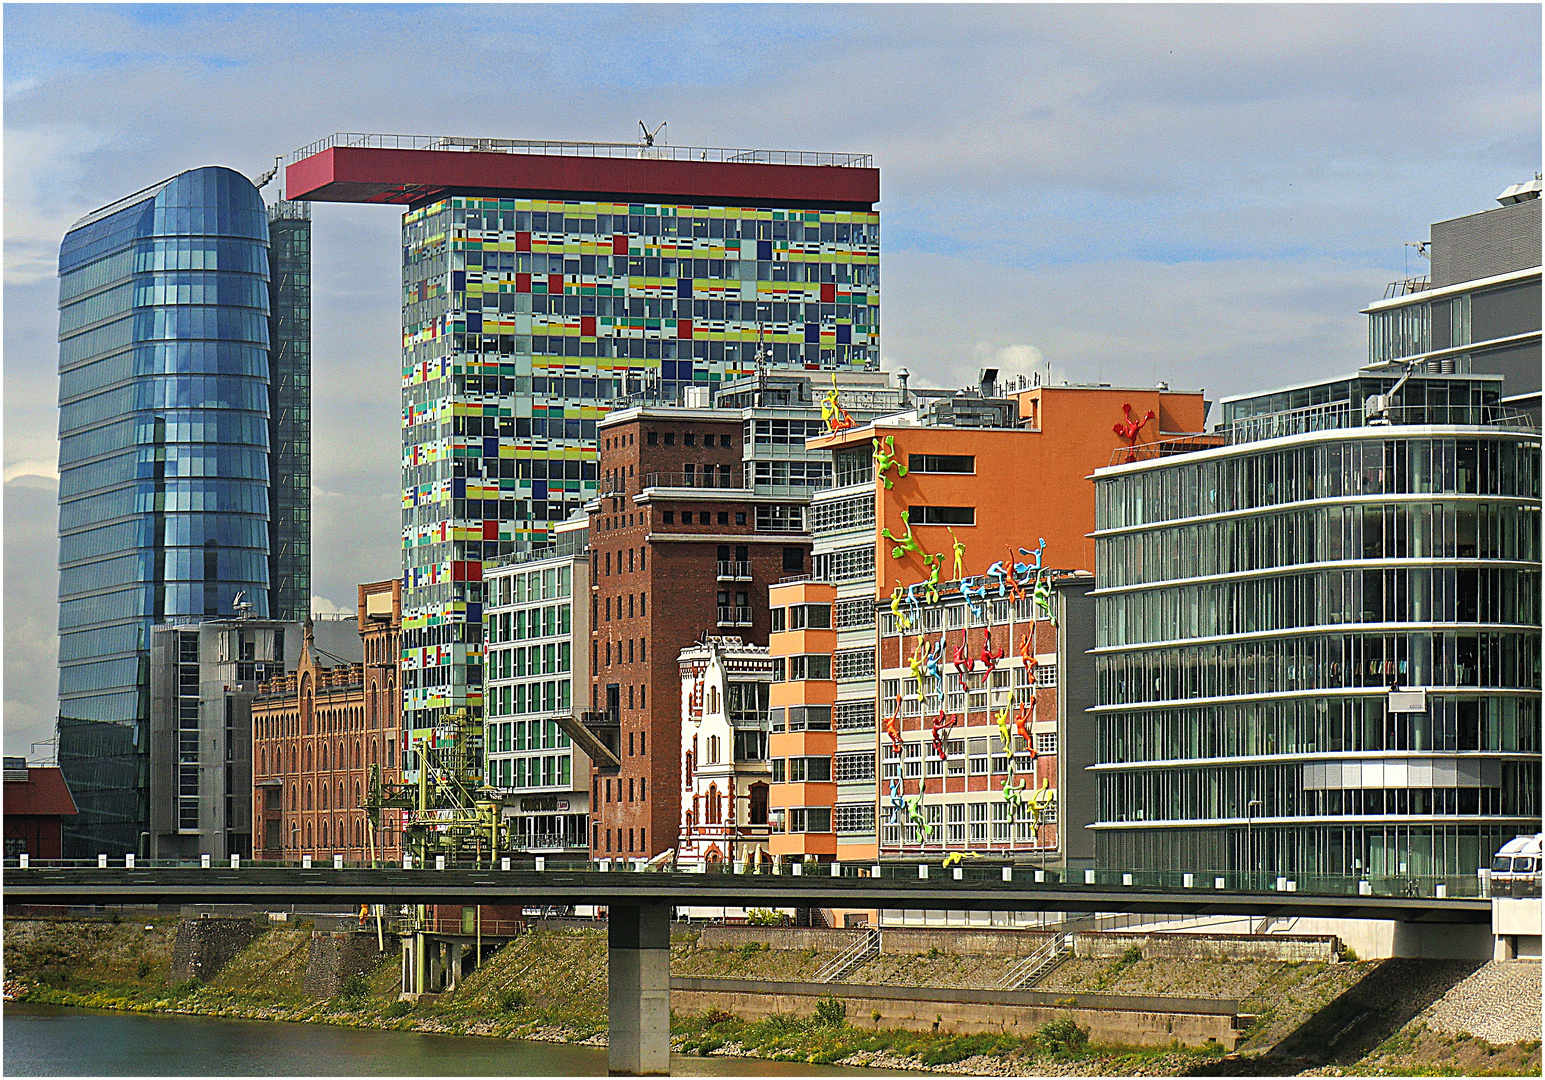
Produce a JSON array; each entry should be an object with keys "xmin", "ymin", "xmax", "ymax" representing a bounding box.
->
[{"xmin": 677, "ymin": 637, "xmax": 773, "ymax": 870}]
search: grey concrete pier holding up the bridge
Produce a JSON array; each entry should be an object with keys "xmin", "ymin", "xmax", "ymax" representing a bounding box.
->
[{"xmin": 606, "ymin": 904, "xmax": 671, "ymax": 1077}]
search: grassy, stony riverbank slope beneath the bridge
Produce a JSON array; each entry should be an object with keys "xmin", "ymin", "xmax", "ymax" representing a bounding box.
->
[{"xmin": 5, "ymin": 919, "xmax": 1539, "ymax": 1075}]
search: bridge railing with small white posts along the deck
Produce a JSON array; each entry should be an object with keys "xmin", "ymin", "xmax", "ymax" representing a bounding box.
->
[{"xmin": 3, "ymin": 853, "xmax": 1491, "ymax": 899}]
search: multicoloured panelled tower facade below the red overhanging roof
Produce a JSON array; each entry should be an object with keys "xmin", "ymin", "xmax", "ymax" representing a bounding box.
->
[{"xmin": 402, "ymin": 198, "xmax": 879, "ymax": 728}]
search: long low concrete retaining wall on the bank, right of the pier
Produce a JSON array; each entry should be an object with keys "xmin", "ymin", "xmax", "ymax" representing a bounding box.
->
[{"xmin": 671, "ymin": 980, "xmax": 1241, "ymax": 1051}]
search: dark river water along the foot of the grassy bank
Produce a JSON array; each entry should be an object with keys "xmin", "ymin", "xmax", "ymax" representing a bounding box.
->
[{"xmin": 5, "ymin": 1003, "xmax": 907, "ymax": 1077}]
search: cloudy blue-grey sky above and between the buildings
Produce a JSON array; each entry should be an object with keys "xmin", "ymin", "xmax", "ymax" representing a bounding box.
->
[{"xmin": 3, "ymin": 3, "xmax": 1540, "ymax": 757}]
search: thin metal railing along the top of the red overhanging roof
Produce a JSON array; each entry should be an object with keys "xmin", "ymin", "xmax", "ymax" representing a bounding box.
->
[{"xmin": 284, "ymin": 131, "xmax": 874, "ymax": 168}]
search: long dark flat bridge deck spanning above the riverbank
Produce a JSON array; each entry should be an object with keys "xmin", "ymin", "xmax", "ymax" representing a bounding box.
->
[{"xmin": 3, "ymin": 867, "xmax": 1491, "ymax": 924}]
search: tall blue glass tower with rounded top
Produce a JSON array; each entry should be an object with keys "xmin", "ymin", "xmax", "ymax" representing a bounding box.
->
[{"xmin": 59, "ymin": 167, "xmax": 278, "ymax": 858}]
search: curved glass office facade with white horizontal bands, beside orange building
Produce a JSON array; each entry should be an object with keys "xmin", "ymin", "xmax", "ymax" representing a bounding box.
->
[{"xmin": 1094, "ymin": 426, "xmax": 1540, "ymax": 876}]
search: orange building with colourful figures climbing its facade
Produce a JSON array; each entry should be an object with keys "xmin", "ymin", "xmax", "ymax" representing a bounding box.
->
[{"xmin": 769, "ymin": 385, "xmax": 1207, "ymax": 861}]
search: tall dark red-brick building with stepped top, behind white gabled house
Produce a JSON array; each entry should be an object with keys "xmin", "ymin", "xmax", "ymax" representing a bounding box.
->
[{"xmin": 587, "ymin": 408, "xmax": 810, "ymax": 859}]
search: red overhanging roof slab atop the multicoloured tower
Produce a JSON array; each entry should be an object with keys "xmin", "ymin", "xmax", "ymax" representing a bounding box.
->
[{"xmin": 284, "ymin": 147, "xmax": 879, "ymax": 210}]
